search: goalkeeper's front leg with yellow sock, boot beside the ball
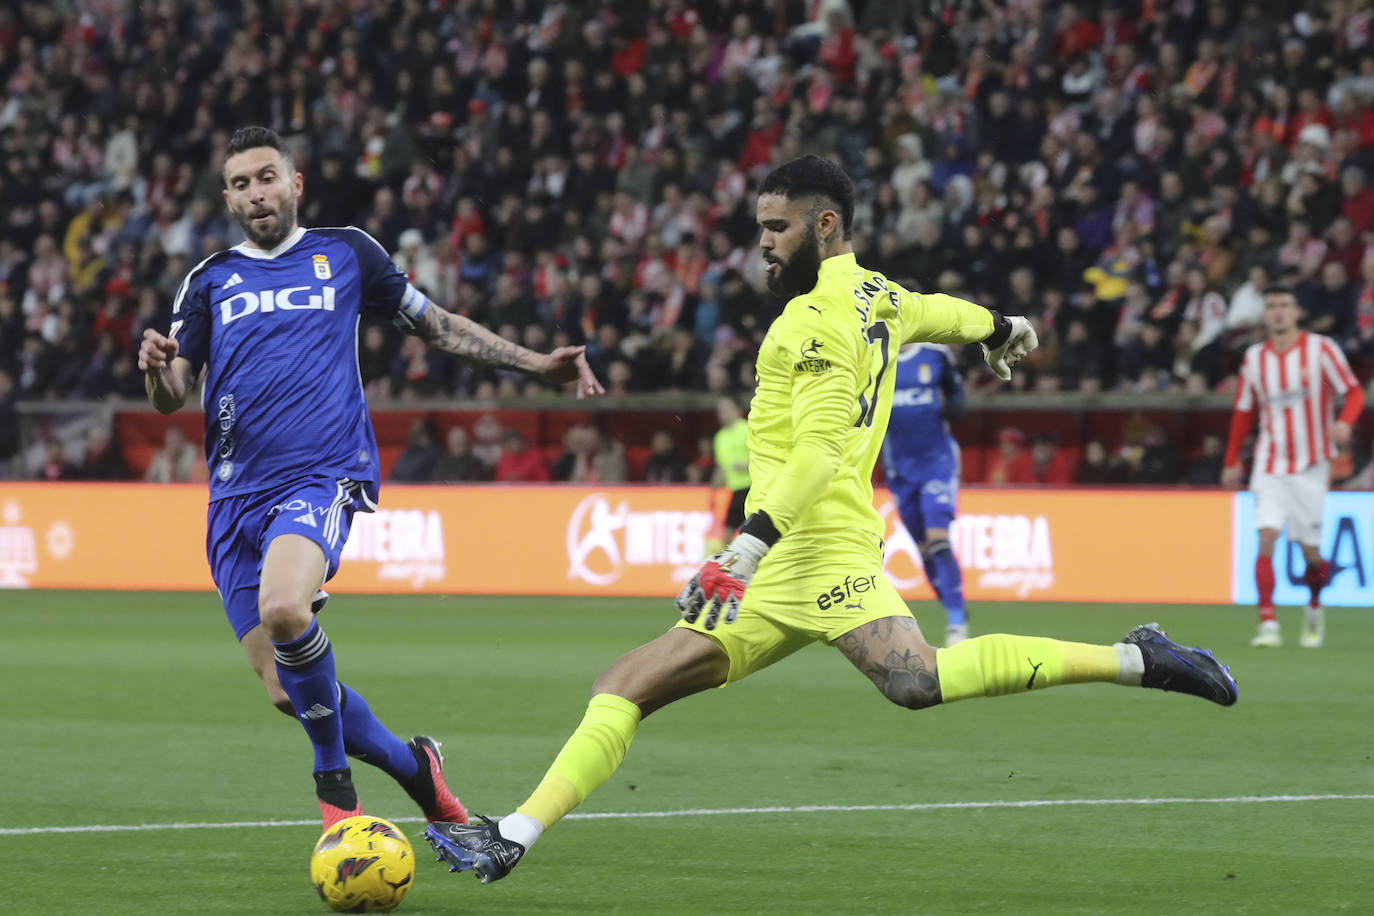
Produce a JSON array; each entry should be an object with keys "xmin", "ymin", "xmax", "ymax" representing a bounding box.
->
[{"xmin": 425, "ymin": 629, "xmax": 730, "ymax": 884}]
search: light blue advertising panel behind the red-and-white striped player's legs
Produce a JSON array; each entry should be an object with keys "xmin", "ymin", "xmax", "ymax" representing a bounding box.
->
[{"xmin": 1232, "ymin": 493, "xmax": 1374, "ymax": 607}]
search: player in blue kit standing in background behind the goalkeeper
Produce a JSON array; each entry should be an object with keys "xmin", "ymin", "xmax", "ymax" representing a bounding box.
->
[{"xmin": 882, "ymin": 343, "xmax": 969, "ymax": 645}]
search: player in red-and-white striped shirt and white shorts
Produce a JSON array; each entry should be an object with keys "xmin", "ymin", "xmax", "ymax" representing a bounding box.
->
[{"xmin": 1221, "ymin": 287, "xmax": 1364, "ymax": 648}]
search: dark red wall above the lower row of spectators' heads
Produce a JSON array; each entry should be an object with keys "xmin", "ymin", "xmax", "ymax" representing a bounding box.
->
[{"xmin": 10, "ymin": 401, "xmax": 1247, "ymax": 483}]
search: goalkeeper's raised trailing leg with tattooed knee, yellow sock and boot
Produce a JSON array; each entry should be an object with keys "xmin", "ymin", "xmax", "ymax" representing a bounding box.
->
[{"xmin": 834, "ymin": 617, "xmax": 1237, "ymax": 709}]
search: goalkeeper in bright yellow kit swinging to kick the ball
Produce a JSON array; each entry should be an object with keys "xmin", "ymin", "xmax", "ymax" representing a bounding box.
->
[{"xmin": 426, "ymin": 155, "xmax": 1237, "ymax": 883}]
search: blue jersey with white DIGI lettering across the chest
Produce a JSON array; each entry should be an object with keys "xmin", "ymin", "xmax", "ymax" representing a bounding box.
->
[{"xmin": 170, "ymin": 227, "xmax": 427, "ymax": 504}]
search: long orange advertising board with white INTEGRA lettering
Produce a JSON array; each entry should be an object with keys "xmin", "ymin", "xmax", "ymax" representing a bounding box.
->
[{"xmin": 0, "ymin": 483, "xmax": 1232, "ymax": 603}]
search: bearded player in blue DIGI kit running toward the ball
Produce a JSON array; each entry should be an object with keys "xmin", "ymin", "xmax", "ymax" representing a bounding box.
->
[{"xmin": 139, "ymin": 128, "xmax": 602, "ymax": 828}]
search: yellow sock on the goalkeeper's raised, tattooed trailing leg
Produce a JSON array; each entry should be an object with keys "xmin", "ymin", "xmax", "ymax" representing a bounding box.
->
[{"xmin": 936, "ymin": 633, "xmax": 1121, "ymax": 703}]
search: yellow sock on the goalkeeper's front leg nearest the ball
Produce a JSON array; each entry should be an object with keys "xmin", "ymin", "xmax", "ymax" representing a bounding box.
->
[{"xmin": 515, "ymin": 694, "xmax": 639, "ymax": 828}]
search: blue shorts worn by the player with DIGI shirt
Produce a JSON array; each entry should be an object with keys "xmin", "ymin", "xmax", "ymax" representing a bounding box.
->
[{"xmin": 205, "ymin": 477, "xmax": 372, "ymax": 640}]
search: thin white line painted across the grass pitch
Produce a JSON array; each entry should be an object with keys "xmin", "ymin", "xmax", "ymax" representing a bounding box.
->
[{"xmin": 0, "ymin": 794, "xmax": 1374, "ymax": 836}]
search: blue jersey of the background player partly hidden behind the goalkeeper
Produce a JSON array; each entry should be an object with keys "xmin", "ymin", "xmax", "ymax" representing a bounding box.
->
[{"xmin": 882, "ymin": 343, "xmax": 963, "ymax": 483}]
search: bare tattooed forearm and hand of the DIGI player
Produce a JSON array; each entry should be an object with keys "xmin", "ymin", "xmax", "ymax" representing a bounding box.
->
[{"xmin": 412, "ymin": 302, "xmax": 605, "ymax": 398}]
